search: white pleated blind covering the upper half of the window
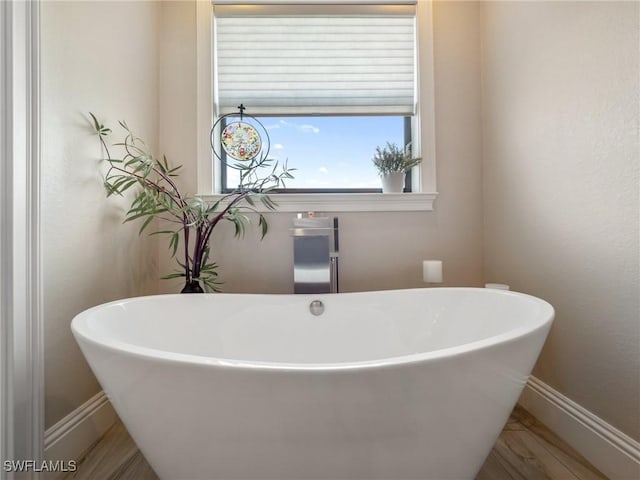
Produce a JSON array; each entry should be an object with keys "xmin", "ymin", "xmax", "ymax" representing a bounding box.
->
[{"xmin": 214, "ymin": 4, "xmax": 417, "ymax": 115}]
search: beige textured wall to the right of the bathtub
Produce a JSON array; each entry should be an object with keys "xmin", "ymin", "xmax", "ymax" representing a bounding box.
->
[{"xmin": 482, "ymin": 2, "xmax": 640, "ymax": 440}]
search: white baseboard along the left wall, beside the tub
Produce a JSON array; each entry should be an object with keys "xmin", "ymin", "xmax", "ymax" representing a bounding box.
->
[{"xmin": 44, "ymin": 391, "xmax": 118, "ymax": 461}]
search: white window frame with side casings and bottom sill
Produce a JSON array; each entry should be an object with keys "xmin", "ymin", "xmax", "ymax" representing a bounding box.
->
[{"xmin": 196, "ymin": 0, "xmax": 438, "ymax": 212}]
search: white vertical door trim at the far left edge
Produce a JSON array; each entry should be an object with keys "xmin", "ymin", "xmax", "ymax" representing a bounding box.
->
[{"xmin": 0, "ymin": 2, "xmax": 44, "ymax": 479}]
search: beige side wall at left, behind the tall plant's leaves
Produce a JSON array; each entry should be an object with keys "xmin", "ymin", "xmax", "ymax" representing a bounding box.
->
[{"xmin": 41, "ymin": 1, "xmax": 157, "ymax": 427}]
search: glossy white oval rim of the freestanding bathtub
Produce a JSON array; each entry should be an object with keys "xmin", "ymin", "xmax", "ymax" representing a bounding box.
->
[{"xmin": 71, "ymin": 287, "xmax": 555, "ymax": 372}]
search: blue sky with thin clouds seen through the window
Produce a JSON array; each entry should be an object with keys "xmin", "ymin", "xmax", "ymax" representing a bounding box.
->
[{"xmin": 229, "ymin": 116, "xmax": 404, "ymax": 188}]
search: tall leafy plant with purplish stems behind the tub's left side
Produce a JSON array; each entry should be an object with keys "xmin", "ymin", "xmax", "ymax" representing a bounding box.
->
[{"xmin": 89, "ymin": 113, "xmax": 293, "ymax": 293}]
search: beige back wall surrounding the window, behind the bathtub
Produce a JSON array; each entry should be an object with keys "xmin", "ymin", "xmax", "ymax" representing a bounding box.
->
[{"xmin": 160, "ymin": 2, "xmax": 483, "ymax": 293}]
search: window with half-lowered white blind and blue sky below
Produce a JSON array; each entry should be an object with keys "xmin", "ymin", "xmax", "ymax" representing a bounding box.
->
[{"xmin": 213, "ymin": 3, "xmax": 419, "ymax": 192}]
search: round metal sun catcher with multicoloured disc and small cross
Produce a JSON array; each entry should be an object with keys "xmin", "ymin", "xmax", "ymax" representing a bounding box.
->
[{"xmin": 211, "ymin": 104, "xmax": 269, "ymax": 162}]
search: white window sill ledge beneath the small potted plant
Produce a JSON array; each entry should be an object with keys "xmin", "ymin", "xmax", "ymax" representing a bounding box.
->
[{"xmin": 201, "ymin": 193, "xmax": 438, "ymax": 213}]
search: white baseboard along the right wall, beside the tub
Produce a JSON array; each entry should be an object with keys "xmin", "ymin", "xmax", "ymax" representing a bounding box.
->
[{"xmin": 519, "ymin": 376, "xmax": 640, "ymax": 480}]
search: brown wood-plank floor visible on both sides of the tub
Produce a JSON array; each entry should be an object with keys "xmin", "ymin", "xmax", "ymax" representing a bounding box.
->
[{"xmin": 63, "ymin": 407, "xmax": 607, "ymax": 480}]
